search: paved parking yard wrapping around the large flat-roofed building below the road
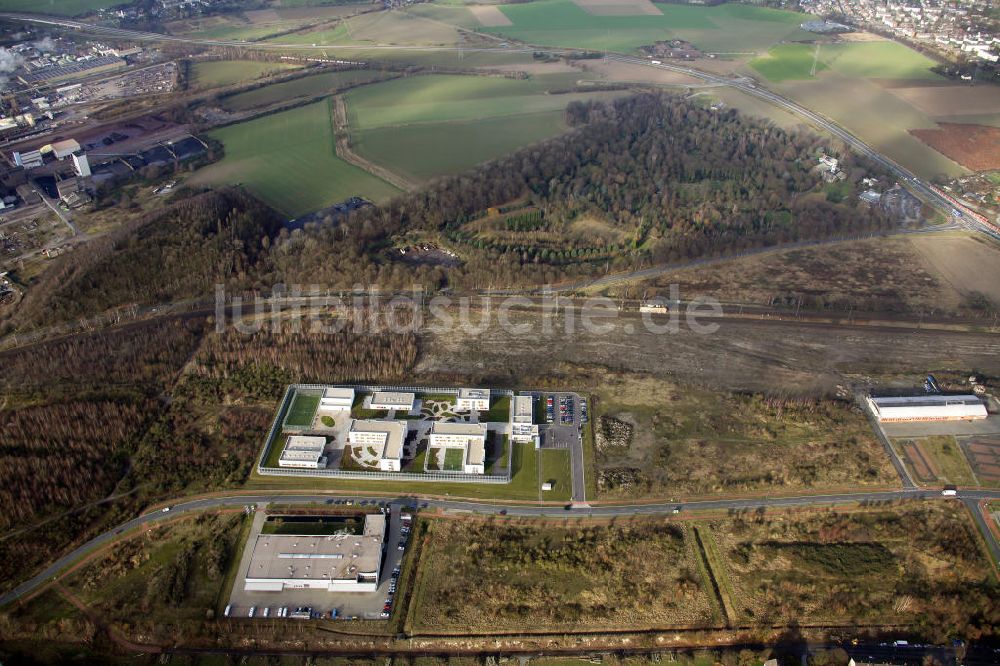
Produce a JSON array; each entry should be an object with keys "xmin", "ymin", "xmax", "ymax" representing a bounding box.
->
[{"xmin": 229, "ymin": 500, "xmax": 410, "ymax": 620}]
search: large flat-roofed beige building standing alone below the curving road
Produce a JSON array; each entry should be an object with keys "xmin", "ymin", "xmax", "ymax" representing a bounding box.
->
[{"xmin": 243, "ymin": 513, "xmax": 385, "ymax": 592}]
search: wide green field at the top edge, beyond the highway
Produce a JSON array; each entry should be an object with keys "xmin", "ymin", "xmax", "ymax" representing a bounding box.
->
[{"xmin": 474, "ymin": 0, "xmax": 813, "ymax": 54}]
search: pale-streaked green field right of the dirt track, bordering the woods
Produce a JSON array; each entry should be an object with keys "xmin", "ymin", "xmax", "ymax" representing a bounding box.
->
[{"xmin": 345, "ymin": 72, "xmax": 623, "ymax": 182}]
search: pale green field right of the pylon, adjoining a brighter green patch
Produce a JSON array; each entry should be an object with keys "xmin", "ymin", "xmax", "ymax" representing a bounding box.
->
[{"xmin": 820, "ymin": 41, "xmax": 943, "ymax": 80}]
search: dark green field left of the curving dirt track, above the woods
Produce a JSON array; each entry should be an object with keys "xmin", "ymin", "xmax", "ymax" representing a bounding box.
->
[{"xmin": 189, "ymin": 101, "xmax": 397, "ymax": 217}]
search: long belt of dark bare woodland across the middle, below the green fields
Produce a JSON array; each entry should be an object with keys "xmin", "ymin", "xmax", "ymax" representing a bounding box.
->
[{"xmin": 0, "ymin": 93, "xmax": 894, "ymax": 332}]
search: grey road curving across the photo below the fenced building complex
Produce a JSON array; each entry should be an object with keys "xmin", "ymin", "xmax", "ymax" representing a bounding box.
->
[{"xmin": 0, "ymin": 482, "xmax": 1000, "ymax": 606}]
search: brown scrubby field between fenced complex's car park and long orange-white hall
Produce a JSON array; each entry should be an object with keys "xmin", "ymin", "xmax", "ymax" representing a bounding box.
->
[{"xmin": 593, "ymin": 375, "xmax": 898, "ymax": 499}]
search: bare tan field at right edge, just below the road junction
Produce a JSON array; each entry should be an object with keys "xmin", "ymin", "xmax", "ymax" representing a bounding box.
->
[{"xmin": 908, "ymin": 234, "xmax": 1000, "ymax": 307}]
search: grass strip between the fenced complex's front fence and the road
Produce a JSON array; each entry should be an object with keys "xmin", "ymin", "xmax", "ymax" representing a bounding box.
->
[{"xmin": 245, "ymin": 444, "xmax": 557, "ymax": 498}]
